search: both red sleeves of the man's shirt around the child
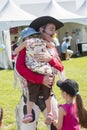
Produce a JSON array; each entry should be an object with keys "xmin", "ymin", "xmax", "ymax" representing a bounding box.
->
[{"xmin": 16, "ymin": 49, "xmax": 64, "ymax": 84}]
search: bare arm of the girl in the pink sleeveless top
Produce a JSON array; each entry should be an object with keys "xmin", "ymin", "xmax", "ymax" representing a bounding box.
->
[{"xmin": 53, "ymin": 107, "xmax": 66, "ymax": 130}]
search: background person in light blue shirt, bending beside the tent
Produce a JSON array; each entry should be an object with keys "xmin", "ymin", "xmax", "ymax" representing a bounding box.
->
[{"xmin": 61, "ymin": 39, "xmax": 73, "ymax": 60}]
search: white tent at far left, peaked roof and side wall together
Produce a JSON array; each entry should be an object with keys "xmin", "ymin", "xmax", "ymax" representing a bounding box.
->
[{"xmin": 0, "ymin": 0, "xmax": 36, "ymax": 69}]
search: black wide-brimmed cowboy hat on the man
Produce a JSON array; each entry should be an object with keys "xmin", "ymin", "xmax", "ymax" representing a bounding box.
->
[{"xmin": 29, "ymin": 16, "xmax": 64, "ymax": 31}]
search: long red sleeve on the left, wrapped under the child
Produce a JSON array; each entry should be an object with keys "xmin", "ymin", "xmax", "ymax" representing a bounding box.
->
[{"xmin": 16, "ymin": 49, "xmax": 44, "ymax": 84}]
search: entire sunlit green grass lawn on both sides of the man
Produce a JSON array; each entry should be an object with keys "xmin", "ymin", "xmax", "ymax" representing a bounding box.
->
[{"xmin": 0, "ymin": 56, "xmax": 87, "ymax": 130}]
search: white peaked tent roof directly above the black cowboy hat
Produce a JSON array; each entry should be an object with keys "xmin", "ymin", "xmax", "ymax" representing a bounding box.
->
[{"xmin": 38, "ymin": 0, "xmax": 85, "ymax": 24}]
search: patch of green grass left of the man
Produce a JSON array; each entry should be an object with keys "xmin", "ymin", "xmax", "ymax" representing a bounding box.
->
[{"xmin": 0, "ymin": 70, "xmax": 21, "ymax": 130}]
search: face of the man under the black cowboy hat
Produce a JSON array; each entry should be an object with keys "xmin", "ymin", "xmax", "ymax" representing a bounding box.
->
[{"xmin": 45, "ymin": 23, "xmax": 56, "ymax": 37}]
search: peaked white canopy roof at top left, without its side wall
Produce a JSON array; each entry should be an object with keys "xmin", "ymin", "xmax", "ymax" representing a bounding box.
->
[{"xmin": 0, "ymin": 0, "xmax": 36, "ymax": 30}]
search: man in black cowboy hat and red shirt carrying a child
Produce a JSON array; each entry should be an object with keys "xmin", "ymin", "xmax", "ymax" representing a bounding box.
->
[{"xmin": 16, "ymin": 16, "xmax": 64, "ymax": 130}]
